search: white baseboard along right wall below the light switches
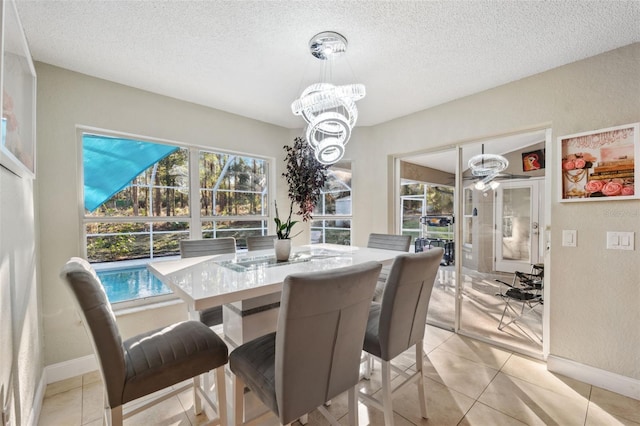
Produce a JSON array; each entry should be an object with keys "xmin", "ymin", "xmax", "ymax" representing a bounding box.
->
[{"xmin": 547, "ymin": 355, "xmax": 640, "ymax": 400}]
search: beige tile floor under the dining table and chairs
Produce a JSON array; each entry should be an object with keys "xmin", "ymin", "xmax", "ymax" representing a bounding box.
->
[{"xmin": 39, "ymin": 326, "xmax": 640, "ymax": 426}]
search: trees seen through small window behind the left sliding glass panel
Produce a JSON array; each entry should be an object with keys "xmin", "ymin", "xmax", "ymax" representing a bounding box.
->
[{"xmin": 400, "ymin": 180, "xmax": 454, "ymax": 240}]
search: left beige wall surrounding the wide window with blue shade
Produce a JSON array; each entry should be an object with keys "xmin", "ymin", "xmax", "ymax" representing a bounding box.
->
[{"xmin": 36, "ymin": 63, "xmax": 291, "ymax": 365}]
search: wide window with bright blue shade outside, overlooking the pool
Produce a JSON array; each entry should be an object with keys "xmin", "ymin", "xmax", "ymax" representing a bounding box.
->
[{"xmin": 82, "ymin": 133, "xmax": 269, "ymax": 299}]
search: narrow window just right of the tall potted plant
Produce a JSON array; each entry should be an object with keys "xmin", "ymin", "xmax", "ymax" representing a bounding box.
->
[{"xmin": 311, "ymin": 161, "xmax": 352, "ymax": 245}]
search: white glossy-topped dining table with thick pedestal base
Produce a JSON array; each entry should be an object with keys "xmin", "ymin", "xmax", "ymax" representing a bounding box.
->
[{"xmin": 147, "ymin": 244, "xmax": 401, "ymax": 345}]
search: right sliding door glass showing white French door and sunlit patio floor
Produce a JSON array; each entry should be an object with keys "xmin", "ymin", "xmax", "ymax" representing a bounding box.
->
[{"xmin": 458, "ymin": 142, "xmax": 544, "ymax": 355}]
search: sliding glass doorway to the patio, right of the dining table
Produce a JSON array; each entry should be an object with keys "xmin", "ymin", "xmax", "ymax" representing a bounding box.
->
[{"xmin": 396, "ymin": 129, "xmax": 550, "ymax": 358}]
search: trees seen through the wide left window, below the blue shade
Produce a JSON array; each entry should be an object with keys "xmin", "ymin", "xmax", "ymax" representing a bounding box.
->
[{"xmin": 84, "ymin": 136, "xmax": 268, "ymax": 262}]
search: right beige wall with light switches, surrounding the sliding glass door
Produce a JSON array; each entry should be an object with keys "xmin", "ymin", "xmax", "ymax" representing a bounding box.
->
[{"xmin": 349, "ymin": 43, "xmax": 640, "ymax": 379}]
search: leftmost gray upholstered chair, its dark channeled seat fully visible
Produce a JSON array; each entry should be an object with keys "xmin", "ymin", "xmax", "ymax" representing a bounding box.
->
[{"xmin": 60, "ymin": 258, "xmax": 228, "ymax": 425}]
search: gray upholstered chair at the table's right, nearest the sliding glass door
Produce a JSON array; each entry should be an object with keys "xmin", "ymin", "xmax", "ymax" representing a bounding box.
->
[{"xmin": 359, "ymin": 247, "xmax": 444, "ymax": 426}]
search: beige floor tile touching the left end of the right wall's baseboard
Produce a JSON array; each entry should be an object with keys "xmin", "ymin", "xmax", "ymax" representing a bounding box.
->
[{"xmin": 500, "ymin": 354, "xmax": 591, "ymax": 399}]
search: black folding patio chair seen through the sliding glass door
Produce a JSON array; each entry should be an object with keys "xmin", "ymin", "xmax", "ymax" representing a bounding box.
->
[{"xmin": 496, "ymin": 263, "xmax": 544, "ymax": 342}]
